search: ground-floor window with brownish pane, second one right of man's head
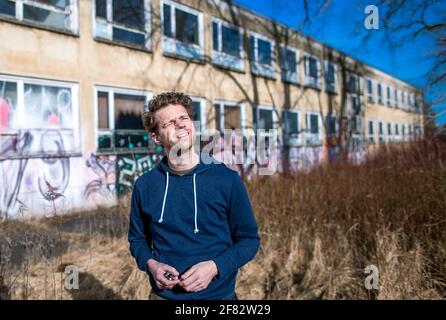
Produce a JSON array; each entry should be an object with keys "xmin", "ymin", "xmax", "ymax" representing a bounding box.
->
[{"xmin": 214, "ymin": 102, "xmax": 243, "ymax": 133}]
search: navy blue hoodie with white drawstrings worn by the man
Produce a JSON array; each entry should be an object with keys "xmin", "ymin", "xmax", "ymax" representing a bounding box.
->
[{"xmin": 128, "ymin": 154, "xmax": 260, "ymax": 300}]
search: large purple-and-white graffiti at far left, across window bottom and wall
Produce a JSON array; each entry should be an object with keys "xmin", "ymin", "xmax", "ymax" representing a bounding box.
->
[{"xmin": 0, "ymin": 129, "xmax": 70, "ymax": 218}]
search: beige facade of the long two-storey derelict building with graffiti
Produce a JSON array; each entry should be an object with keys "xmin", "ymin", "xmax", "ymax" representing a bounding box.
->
[{"xmin": 0, "ymin": 0, "xmax": 423, "ymax": 216}]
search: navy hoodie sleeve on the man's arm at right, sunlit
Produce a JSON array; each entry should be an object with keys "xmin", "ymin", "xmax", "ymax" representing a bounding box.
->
[{"xmin": 213, "ymin": 173, "xmax": 260, "ymax": 277}]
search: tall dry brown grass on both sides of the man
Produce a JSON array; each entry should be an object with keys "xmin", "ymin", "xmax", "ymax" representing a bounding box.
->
[{"xmin": 0, "ymin": 138, "xmax": 446, "ymax": 299}]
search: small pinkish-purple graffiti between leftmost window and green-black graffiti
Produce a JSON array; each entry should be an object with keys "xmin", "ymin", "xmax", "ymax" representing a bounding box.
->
[{"xmin": 84, "ymin": 153, "xmax": 115, "ymax": 199}]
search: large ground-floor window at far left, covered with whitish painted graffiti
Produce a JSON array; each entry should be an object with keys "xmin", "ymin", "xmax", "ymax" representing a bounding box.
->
[{"xmin": 0, "ymin": 75, "xmax": 80, "ymax": 157}]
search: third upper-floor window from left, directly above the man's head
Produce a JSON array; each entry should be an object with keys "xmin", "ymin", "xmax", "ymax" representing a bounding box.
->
[{"xmin": 161, "ymin": 0, "xmax": 204, "ymax": 60}]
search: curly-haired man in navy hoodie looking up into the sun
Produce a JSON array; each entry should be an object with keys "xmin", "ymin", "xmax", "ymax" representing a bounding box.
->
[{"xmin": 128, "ymin": 92, "xmax": 260, "ymax": 300}]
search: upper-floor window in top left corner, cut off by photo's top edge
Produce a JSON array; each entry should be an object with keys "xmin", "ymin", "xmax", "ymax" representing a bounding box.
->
[{"xmin": 0, "ymin": 0, "xmax": 78, "ymax": 33}]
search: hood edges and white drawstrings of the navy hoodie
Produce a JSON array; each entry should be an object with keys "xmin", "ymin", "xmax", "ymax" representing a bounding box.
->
[{"xmin": 157, "ymin": 153, "xmax": 221, "ymax": 233}]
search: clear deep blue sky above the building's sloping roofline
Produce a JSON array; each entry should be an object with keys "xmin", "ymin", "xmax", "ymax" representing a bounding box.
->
[{"xmin": 234, "ymin": 0, "xmax": 446, "ymax": 124}]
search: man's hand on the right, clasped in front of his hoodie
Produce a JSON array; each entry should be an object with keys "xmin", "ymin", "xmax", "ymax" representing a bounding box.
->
[{"xmin": 180, "ymin": 260, "xmax": 218, "ymax": 292}]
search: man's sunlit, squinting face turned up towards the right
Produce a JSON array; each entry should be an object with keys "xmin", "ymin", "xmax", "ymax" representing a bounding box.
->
[{"xmin": 151, "ymin": 104, "xmax": 195, "ymax": 150}]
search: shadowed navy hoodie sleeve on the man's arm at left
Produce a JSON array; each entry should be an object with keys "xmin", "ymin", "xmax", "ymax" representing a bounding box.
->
[{"xmin": 128, "ymin": 183, "xmax": 153, "ymax": 272}]
